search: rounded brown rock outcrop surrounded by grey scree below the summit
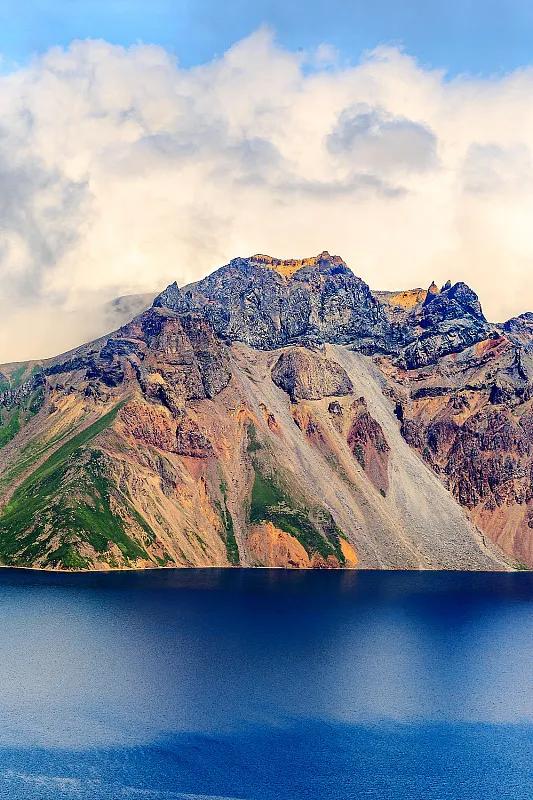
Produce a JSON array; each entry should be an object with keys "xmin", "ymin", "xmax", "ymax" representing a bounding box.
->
[{"xmin": 272, "ymin": 347, "xmax": 353, "ymax": 402}]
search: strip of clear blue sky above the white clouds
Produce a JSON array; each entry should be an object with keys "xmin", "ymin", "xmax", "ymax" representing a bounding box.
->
[{"xmin": 0, "ymin": 0, "xmax": 533, "ymax": 76}]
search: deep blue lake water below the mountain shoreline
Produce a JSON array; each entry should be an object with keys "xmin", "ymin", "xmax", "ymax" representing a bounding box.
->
[{"xmin": 0, "ymin": 570, "xmax": 533, "ymax": 800}]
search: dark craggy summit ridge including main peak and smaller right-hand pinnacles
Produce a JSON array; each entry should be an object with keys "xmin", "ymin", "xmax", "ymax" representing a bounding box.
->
[{"xmin": 154, "ymin": 252, "xmax": 491, "ymax": 369}]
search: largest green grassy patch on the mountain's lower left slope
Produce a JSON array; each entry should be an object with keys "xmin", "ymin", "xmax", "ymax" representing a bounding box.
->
[{"xmin": 0, "ymin": 404, "xmax": 153, "ymax": 569}]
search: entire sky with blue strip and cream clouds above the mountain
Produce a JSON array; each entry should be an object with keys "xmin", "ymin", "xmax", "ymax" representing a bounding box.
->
[{"xmin": 0, "ymin": 0, "xmax": 533, "ymax": 362}]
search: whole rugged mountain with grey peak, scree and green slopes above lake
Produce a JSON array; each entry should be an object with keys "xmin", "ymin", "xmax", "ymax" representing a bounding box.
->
[{"xmin": 0, "ymin": 252, "xmax": 533, "ymax": 569}]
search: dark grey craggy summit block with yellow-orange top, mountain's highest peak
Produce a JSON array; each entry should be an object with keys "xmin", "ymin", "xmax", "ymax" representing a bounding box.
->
[{"xmin": 154, "ymin": 252, "xmax": 394, "ymax": 350}]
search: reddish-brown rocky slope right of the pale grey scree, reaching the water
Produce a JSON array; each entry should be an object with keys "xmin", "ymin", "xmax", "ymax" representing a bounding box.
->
[{"xmin": 390, "ymin": 332, "xmax": 533, "ymax": 564}]
